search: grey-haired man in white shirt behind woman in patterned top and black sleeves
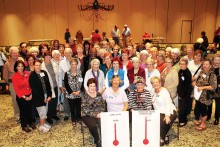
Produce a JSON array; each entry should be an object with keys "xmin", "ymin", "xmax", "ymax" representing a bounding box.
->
[{"xmin": 58, "ymin": 48, "xmax": 73, "ymax": 120}]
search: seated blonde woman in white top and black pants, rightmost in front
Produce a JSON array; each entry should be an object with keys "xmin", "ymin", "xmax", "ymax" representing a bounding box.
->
[{"xmin": 151, "ymin": 77, "xmax": 177, "ymax": 146}]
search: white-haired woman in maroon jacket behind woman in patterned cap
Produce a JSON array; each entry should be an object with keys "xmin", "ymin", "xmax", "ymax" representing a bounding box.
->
[{"xmin": 127, "ymin": 57, "xmax": 145, "ymax": 90}]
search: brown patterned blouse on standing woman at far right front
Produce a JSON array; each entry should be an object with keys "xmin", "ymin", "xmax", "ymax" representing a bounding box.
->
[{"xmin": 196, "ymin": 70, "xmax": 217, "ymax": 105}]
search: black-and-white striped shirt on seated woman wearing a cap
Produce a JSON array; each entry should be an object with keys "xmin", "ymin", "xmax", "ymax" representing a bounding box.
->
[{"xmin": 128, "ymin": 90, "xmax": 152, "ymax": 110}]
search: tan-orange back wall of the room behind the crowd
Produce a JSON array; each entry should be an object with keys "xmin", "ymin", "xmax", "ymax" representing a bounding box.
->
[{"xmin": 0, "ymin": 0, "xmax": 220, "ymax": 45}]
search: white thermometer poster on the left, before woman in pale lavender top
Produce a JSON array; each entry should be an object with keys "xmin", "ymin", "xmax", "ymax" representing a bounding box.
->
[{"xmin": 101, "ymin": 111, "xmax": 130, "ymax": 147}]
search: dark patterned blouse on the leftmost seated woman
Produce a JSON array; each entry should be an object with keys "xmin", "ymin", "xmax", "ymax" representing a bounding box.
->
[{"xmin": 82, "ymin": 92, "xmax": 105, "ymax": 117}]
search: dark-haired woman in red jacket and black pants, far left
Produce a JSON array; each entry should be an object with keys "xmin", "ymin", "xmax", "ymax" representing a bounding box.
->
[{"xmin": 12, "ymin": 60, "xmax": 36, "ymax": 133}]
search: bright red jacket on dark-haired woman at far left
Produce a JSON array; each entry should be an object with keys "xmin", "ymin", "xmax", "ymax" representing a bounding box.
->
[{"xmin": 12, "ymin": 71, "xmax": 31, "ymax": 98}]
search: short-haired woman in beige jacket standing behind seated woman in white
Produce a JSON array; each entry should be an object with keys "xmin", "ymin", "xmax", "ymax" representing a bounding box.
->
[{"xmin": 160, "ymin": 58, "xmax": 179, "ymax": 99}]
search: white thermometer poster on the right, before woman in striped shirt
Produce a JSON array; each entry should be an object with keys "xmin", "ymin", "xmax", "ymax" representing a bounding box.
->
[{"xmin": 132, "ymin": 110, "xmax": 160, "ymax": 147}]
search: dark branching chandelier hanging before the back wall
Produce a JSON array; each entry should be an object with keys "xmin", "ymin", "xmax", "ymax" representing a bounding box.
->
[{"xmin": 78, "ymin": 0, "xmax": 114, "ymax": 22}]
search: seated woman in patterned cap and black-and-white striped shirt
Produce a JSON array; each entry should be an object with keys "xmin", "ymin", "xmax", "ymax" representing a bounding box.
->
[{"xmin": 128, "ymin": 76, "xmax": 152, "ymax": 111}]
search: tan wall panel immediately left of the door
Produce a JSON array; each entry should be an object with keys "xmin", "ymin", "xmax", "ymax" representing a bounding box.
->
[{"xmin": 166, "ymin": 0, "xmax": 181, "ymax": 43}]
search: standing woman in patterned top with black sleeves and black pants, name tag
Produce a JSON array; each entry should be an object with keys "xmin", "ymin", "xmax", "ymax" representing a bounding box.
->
[{"xmin": 64, "ymin": 58, "xmax": 83, "ymax": 126}]
